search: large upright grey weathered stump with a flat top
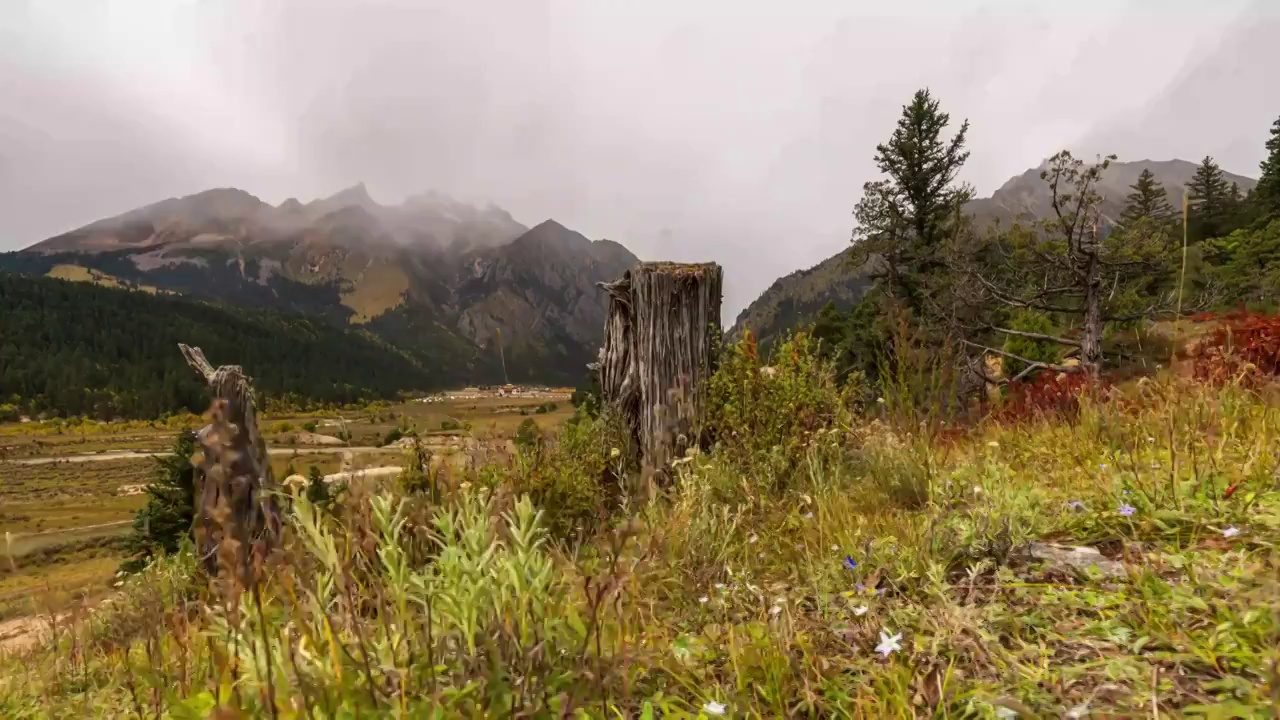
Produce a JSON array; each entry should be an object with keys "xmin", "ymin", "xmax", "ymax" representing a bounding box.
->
[{"xmin": 599, "ymin": 263, "xmax": 723, "ymax": 471}]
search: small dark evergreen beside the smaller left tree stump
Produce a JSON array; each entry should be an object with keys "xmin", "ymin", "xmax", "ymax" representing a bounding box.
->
[{"xmin": 120, "ymin": 430, "xmax": 196, "ymax": 573}]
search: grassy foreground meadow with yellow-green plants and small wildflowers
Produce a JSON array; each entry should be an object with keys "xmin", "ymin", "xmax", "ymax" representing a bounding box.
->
[{"xmin": 0, "ymin": 361, "xmax": 1280, "ymax": 719}]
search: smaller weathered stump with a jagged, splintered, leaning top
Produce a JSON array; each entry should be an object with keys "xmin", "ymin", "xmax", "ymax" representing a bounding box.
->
[{"xmin": 178, "ymin": 345, "xmax": 280, "ymax": 582}]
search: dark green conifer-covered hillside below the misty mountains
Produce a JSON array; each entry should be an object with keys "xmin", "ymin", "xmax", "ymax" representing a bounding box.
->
[{"xmin": 0, "ymin": 273, "xmax": 442, "ymax": 420}]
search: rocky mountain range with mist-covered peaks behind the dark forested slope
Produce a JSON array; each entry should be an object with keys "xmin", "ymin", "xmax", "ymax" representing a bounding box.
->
[{"xmin": 0, "ymin": 184, "xmax": 639, "ymax": 387}]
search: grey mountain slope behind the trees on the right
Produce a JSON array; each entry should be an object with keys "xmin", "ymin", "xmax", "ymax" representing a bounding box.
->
[{"xmin": 730, "ymin": 160, "xmax": 1257, "ymax": 345}]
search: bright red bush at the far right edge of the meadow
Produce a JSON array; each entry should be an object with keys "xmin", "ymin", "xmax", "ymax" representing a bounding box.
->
[{"xmin": 1188, "ymin": 310, "xmax": 1280, "ymax": 384}]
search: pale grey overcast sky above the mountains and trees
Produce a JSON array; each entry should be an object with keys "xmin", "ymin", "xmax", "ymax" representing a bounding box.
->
[{"xmin": 0, "ymin": 0, "xmax": 1280, "ymax": 318}]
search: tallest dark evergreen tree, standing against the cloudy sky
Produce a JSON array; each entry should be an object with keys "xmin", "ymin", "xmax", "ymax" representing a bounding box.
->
[{"xmin": 854, "ymin": 90, "xmax": 973, "ymax": 318}]
